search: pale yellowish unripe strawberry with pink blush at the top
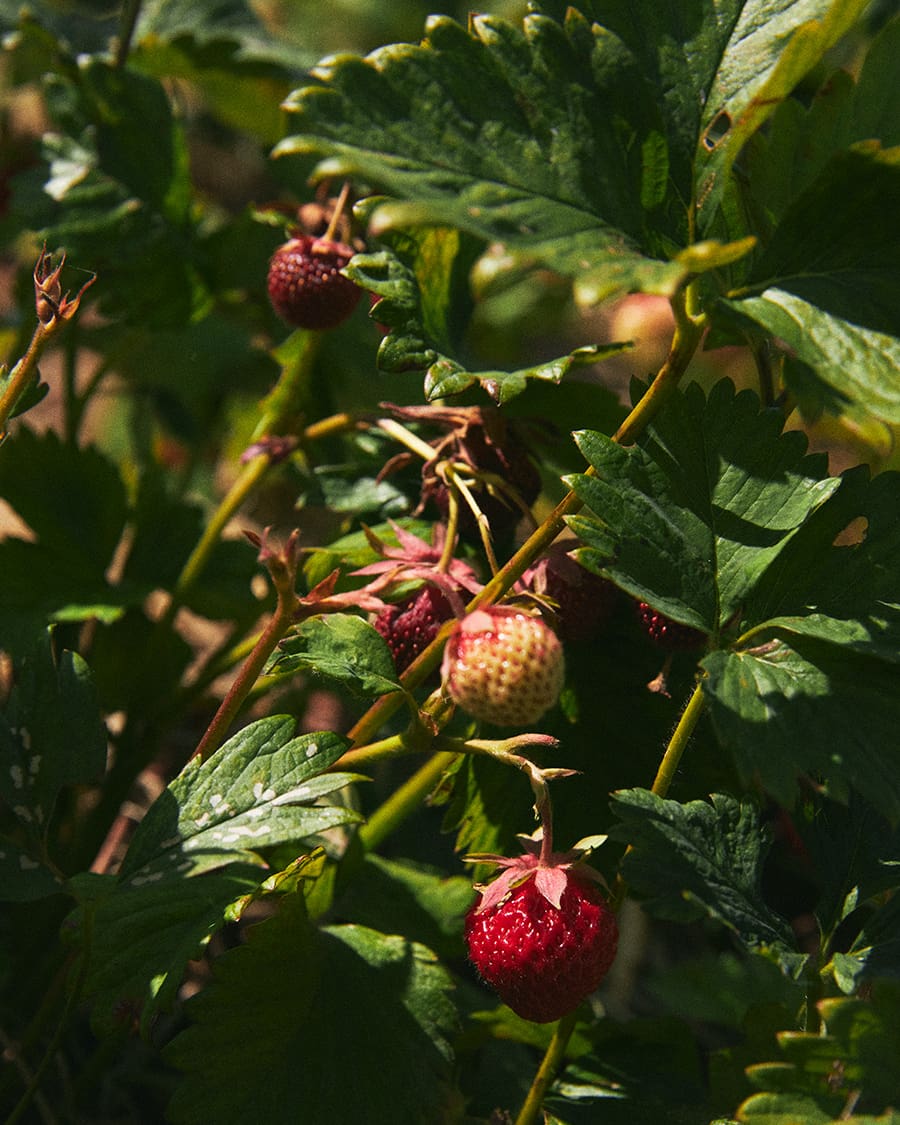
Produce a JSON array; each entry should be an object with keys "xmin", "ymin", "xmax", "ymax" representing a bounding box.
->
[{"xmin": 441, "ymin": 605, "xmax": 565, "ymax": 727}]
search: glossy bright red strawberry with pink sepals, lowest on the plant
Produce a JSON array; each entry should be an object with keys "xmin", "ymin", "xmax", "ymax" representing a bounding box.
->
[{"xmin": 465, "ymin": 840, "xmax": 619, "ymax": 1024}]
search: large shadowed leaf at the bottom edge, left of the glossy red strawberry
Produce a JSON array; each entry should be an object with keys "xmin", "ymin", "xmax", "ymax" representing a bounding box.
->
[{"xmin": 167, "ymin": 896, "xmax": 459, "ymax": 1125}]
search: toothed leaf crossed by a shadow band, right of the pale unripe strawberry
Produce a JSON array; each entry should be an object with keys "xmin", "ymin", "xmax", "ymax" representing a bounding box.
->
[{"xmin": 568, "ymin": 379, "xmax": 839, "ymax": 633}]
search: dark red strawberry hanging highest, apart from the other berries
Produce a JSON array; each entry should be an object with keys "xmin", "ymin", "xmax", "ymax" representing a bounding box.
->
[{"xmin": 268, "ymin": 234, "xmax": 362, "ymax": 330}]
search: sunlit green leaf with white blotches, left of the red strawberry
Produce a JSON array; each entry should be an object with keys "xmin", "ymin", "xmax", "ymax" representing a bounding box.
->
[{"xmin": 120, "ymin": 716, "xmax": 361, "ymax": 887}]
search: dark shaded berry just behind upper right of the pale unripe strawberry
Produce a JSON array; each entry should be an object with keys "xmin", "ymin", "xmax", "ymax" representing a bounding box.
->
[{"xmin": 522, "ymin": 539, "xmax": 618, "ymax": 641}]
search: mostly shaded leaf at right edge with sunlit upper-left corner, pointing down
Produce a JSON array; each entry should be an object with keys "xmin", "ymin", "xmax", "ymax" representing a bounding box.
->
[{"xmin": 701, "ymin": 643, "xmax": 900, "ymax": 819}]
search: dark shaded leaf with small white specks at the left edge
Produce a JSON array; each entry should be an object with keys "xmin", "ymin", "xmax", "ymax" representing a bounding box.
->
[{"xmin": 0, "ymin": 632, "xmax": 107, "ymax": 841}]
